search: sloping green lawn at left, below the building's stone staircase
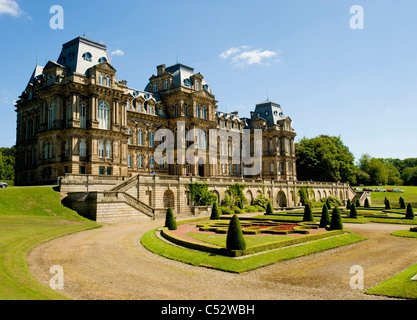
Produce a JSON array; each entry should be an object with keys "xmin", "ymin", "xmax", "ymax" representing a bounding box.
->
[{"xmin": 0, "ymin": 187, "xmax": 99, "ymax": 300}]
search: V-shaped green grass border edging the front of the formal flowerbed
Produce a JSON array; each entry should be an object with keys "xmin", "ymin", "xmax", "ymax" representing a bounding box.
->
[{"xmin": 141, "ymin": 225, "xmax": 366, "ymax": 273}]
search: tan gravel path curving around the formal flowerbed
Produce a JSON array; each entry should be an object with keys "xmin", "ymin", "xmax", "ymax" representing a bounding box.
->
[{"xmin": 29, "ymin": 221, "xmax": 417, "ymax": 300}]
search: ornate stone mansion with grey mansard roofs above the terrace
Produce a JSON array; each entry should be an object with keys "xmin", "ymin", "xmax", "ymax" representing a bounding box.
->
[{"xmin": 16, "ymin": 37, "xmax": 296, "ymax": 185}]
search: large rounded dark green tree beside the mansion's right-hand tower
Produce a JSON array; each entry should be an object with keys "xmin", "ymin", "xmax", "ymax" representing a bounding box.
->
[{"xmin": 296, "ymin": 135, "xmax": 356, "ymax": 184}]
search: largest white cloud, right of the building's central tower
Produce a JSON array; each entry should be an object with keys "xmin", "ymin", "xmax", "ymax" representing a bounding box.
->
[{"xmin": 220, "ymin": 46, "xmax": 280, "ymax": 67}]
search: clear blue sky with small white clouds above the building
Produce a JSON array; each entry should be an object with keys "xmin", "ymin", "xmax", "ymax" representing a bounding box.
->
[{"xmin": 0, "ymin": 0, "xmax": 417, "ymax": 159}]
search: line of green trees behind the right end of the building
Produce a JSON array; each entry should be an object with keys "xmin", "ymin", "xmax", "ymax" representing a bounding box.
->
[{"xmin": 295, "ymin": 135, "xmax": 417, "ymax": 186}]
